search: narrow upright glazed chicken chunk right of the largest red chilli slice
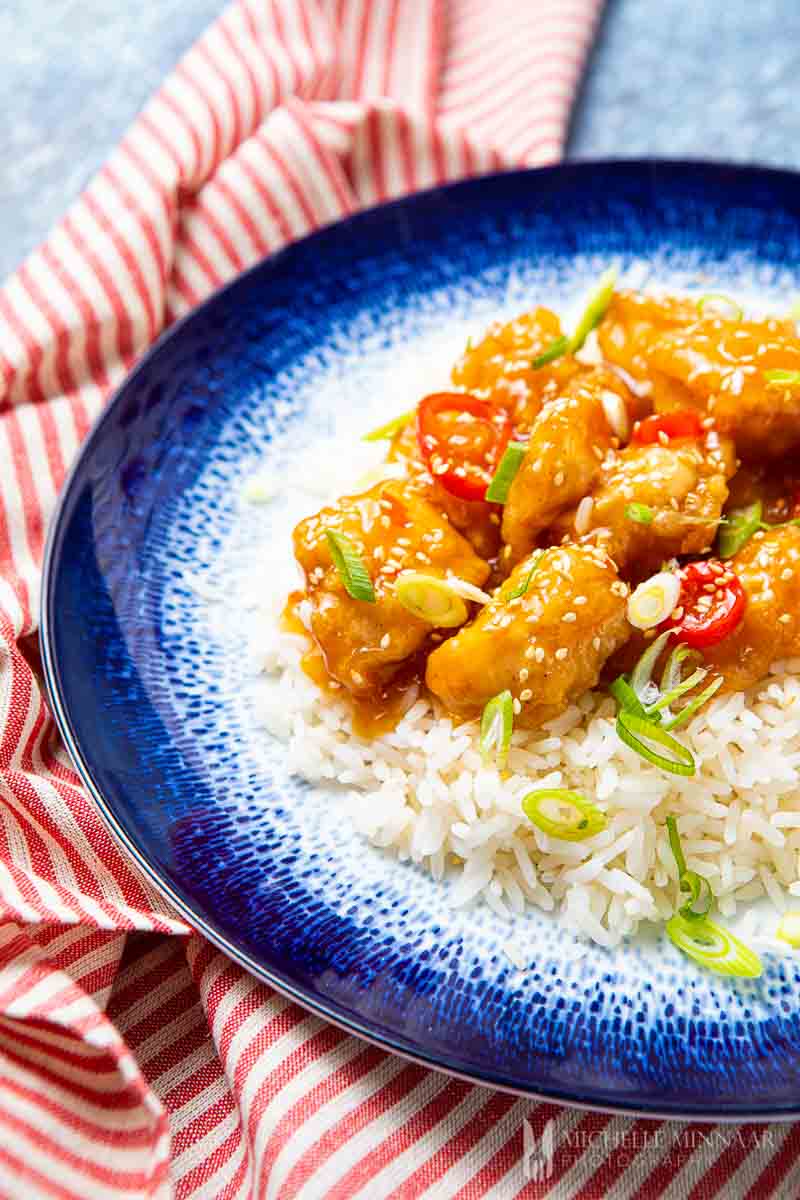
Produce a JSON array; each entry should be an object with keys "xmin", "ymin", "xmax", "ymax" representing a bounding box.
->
[{"xmin": 503, "ymin": 368, "xmax": 630, "ymax": 565}]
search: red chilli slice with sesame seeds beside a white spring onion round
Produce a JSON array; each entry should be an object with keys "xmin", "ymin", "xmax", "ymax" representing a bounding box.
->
[{"xmin": 664, "ymin": 559, "xmax": 747, "ymax": 650}]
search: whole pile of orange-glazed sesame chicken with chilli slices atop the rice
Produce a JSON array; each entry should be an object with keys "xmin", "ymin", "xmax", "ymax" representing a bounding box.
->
[{"xmin": 287, "ymin": 276, "xmax": 800, "ymax": 737}]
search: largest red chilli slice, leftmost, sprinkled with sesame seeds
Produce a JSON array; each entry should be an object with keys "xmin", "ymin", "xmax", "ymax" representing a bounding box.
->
[{"xmin": 416, "ymin": 391, "xmax": 511, "ymax": 500}]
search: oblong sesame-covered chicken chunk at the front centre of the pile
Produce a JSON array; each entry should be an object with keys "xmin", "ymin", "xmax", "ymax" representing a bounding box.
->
[{"xmin": 426, "ymin": 546, "xmax": 631, "ymax": 728}]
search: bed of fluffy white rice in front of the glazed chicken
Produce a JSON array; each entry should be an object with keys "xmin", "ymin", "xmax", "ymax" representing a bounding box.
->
[{"xmin": 257, "ymin": 598, "xmax": 800, "ymax": 940}]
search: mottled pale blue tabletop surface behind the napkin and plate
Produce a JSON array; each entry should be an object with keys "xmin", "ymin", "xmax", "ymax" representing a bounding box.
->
[{"xmin": 0, "ymin": 0, "xmax": 800, "ymax": 277}]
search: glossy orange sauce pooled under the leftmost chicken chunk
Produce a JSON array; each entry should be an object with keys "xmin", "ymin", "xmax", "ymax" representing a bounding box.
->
[{"xmin": 281, "ymin": 592, "xmax": 426, "ymax": 740}]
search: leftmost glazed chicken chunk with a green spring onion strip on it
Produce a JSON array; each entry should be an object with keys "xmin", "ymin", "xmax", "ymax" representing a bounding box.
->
[{"xmin": 294, "ymin": 482, "xmax": 489, "ymax": 697}]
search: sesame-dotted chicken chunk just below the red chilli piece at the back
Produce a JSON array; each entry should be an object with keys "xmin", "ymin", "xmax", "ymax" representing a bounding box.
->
[{"xmin": 553, "ymin": 432, "xmax": 735, "ymax": 576}]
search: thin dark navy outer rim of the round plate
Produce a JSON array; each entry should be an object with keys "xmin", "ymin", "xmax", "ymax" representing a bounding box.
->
[{"xmin": 38, "ymin": 157, "xmax": 800, "ymax": 1124}]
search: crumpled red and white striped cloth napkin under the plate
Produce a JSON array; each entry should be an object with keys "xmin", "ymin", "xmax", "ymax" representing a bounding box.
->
[{"xmin": 0, "ymin": 0, "xmax": 800, "ymax": 1200}]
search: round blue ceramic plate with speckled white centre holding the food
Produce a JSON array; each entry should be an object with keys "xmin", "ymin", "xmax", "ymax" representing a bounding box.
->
[{"xmin": 42, "ymin": 163, "xmax": 800, "ymax": 1117}]
